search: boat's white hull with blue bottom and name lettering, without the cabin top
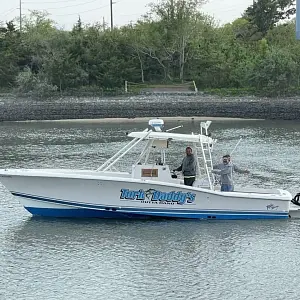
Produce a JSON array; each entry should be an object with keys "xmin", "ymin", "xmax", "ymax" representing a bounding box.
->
[{"xmin": 0, "ymin": 170, "xmax": 292, "ymax": 219}]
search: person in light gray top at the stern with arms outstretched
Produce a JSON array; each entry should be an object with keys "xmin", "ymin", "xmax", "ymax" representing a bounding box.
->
[{"xmin": 212, "ymin": 154, "xmax": 249, "ymax": 192}]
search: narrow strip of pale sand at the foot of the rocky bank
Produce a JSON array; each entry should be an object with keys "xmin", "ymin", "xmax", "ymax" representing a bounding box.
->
[{"xmin": 11, "ymin": 116, "xmax": 265, "ymax": 124}]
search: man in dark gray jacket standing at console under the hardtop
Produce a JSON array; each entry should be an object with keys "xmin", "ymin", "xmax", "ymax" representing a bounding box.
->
[{"xmin": 173, "ymin": 147, "xmax": 196, "ymax": 186}]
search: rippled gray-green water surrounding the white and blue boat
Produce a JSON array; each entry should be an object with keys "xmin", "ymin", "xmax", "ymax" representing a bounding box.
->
[{"xmin": 0, "ymin": 120, "xmax": 300, "ymax": 300}]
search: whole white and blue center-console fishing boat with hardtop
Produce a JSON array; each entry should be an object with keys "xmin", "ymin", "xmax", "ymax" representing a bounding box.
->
[{"xmin": 0, "ymin": 119, "xmax": 300, "ymax": 220}]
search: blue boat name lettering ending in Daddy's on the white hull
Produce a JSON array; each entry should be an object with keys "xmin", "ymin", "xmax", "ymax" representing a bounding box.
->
[{"xmin": 120, "ymin": 189, "xmax": 196, "ymax": 204}]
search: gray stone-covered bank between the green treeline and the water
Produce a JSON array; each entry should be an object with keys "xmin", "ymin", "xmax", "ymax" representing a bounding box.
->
[{"xmin": 0, "ymin": 95, "xmax": 300, "ymax": 123}]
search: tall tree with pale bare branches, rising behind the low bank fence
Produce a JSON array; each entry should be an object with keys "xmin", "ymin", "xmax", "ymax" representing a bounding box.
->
[{"xmin": 138, "ymin": 0, "xmax": 205, "ymax": 81}]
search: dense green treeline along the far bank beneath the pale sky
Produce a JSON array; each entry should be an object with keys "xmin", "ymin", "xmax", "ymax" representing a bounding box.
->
[{"xmin": 0, "ymin": 0, "xmax": 300, "ymax": 96}]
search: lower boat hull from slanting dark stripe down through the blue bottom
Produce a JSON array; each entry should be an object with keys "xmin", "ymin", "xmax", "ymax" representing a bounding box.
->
[{"xmin": 17, "ymin": 193, "xmax": 289, "ymax": 220}]
